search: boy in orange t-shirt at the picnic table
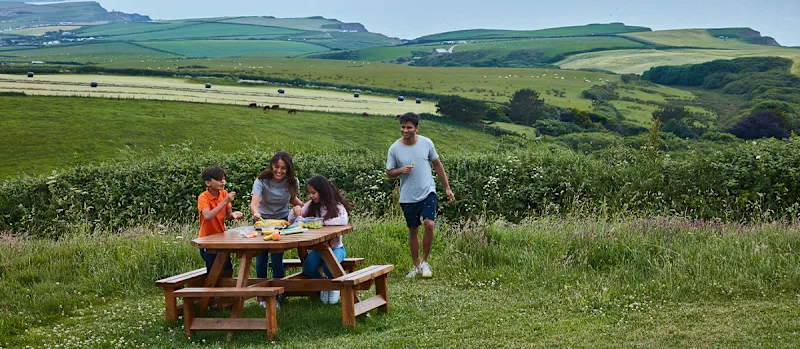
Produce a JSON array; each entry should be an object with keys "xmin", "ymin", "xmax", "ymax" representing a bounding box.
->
[{"xmin": 197, "ymin": 166, "xmax": 242, "ymax": 274}]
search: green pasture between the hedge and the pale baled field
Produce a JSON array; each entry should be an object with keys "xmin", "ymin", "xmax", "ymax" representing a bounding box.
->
[{"xmin": 0, "ymin": 96, "xmax": 497, "ymax": 178}]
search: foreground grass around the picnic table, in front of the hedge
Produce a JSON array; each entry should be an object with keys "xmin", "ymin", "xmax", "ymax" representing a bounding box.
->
[{"xmin": 0, "ymin": 217, "xmax": 800, "ymax": 348}]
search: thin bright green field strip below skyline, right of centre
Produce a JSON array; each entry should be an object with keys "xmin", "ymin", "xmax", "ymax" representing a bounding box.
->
[{"xmin": 414, "ymin": 23, "xmax": 650, "ymax": 42}]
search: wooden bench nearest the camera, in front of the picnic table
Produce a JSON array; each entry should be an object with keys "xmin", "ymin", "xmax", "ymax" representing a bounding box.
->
[{"xmin": 174, "ymin": 287, "xmax": 283, "ymax": 339}]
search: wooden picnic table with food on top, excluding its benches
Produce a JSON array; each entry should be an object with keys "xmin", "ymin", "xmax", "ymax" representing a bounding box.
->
[{"xmin": 192, "ymin": 226, "xmax": 353, "ymax": 334}]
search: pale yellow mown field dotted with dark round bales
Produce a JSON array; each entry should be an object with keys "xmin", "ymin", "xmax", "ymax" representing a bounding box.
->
[{"xmin": 0, "ymin": 74, "xmax": 436, "ymax": 115}]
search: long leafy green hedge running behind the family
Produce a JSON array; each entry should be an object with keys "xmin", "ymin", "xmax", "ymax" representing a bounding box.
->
[{"xmin": 0, "ymin": 139, "xmax": 800, "ymax": 237}]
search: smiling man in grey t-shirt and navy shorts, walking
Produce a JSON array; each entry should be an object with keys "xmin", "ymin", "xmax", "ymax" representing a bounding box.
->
[{"xmin": 386, "ymin": 113, "xmax": 455, "ymax": 278}]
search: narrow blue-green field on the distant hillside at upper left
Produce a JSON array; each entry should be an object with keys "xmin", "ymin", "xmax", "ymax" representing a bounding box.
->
[{"xmin": 141, "ymin": 40, "xmax": 328, "ymax": 57}]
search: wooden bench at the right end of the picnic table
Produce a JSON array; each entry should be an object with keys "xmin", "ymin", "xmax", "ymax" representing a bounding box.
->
[{"xmin": 333, "ymin": 264, "xmax": 394, "ymax": 328}]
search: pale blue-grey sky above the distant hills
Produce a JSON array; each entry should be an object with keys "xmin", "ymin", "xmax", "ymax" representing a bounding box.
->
[{"xmin": 89, "ymin": 0, "xmax": 800, "ymax": 46}]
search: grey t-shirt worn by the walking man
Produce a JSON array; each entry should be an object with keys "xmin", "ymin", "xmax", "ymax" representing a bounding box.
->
[{"xmin": 386, "ymin": 135, "xmax": 439, "ymax": 204}]
